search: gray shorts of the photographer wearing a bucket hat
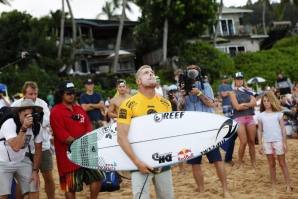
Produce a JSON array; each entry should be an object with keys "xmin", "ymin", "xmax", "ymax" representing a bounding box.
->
[{"xmin": 0, "ymin": 156, "xmax": 38, "ymax": 195}]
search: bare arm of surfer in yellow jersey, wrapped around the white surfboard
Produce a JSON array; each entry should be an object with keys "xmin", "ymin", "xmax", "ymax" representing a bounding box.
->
[{"xmin": 117, "ymin": 123, "xmax": 153, "ymax": 173}]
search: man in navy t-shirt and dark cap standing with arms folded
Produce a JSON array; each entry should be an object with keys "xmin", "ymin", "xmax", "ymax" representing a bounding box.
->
[{"xmin": 80, "ymin": 79, "xmax": 105, "ymax": 130}]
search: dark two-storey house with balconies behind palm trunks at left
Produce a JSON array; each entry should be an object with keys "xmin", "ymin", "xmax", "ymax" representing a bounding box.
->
[{"xmin": 64, "ymin": 19, "xmax": 138, "ymax": 75}]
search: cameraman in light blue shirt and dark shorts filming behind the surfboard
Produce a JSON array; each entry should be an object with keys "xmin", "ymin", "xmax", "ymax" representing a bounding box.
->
[{"xmin": 177, "ymin": 65, "xmax": 230, "ymax": 197}]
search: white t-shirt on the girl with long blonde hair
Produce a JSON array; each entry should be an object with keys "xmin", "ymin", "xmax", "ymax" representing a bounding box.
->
[{"xmin": 258, "ymin": 111, "xmax": 283, "ymax": 142}]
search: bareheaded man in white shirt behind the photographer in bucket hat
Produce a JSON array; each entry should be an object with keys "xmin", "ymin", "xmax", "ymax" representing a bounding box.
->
[{"xmin": 11, "ymin": 81, "xmax": 55, "ymax": 199}]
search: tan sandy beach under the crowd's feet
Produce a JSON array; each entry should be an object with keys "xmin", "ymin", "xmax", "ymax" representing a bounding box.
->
[{"xmin": 40, "ymin": 139, "xmax": 298, "ymax": 199}]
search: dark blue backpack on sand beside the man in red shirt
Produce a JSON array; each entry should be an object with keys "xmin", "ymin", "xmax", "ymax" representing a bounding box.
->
[{"xmin": 100, "ymin": 171, "xmax": 120, "ymax": 192}]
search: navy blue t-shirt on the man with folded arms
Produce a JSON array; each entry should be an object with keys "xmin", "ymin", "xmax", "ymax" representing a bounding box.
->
[{"xmin": 80, "ymin": 92, "xmax": 103, "ymax": 121}]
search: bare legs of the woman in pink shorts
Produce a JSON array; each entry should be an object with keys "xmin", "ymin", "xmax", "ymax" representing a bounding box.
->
[{"xmin": 237, "ymin": 124, "xmax": 256, "ymax": 168}]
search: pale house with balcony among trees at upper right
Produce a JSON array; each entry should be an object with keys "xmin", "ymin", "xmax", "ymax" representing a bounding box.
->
[{"xmin": 201, "ymin": 8, "xmax": 268, "ymax": 57}]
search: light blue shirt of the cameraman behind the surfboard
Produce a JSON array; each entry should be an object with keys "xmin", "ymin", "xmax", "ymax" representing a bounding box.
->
[{"xmin": 178, "ymin": 82, "xmax": 214, "ymax": 113}]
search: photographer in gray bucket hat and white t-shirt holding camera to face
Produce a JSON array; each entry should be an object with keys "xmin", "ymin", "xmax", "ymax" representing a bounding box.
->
[{"xmin": 0, "ymin": 99, "xmax": 43, "ymax": 199}]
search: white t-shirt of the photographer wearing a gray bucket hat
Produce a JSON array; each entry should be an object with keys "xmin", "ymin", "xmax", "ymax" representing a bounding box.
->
[{"xmin": 0, "ymin": 118, "xmax": 43, "ymax": 163}]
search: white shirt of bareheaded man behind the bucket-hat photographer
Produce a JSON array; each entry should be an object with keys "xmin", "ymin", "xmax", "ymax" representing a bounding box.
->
[{"xmin": 11, "ymin": 98, "xmax": 51, "ymax": 153}]
